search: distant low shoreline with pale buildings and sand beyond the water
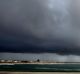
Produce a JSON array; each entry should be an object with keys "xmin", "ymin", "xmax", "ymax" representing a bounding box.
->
[{"xmin": 0, "ymin": 59, "xmax": 80, "ymax": 64}]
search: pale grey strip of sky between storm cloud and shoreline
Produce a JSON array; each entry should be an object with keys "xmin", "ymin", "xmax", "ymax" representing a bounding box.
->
[{"xmin": 0, "ymin": 53, "xmax": 80, "ymax": 62}]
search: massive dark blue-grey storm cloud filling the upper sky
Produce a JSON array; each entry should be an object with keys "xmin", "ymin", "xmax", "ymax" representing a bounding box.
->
[{"xmin": 0, "ymin": 0, "xmax": 80, "ymax": 53}]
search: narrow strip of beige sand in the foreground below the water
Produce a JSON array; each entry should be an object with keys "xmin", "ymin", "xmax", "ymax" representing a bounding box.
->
[{"xmin": 0, "ymin": 72, "xmax": 80, "ymax": 74}]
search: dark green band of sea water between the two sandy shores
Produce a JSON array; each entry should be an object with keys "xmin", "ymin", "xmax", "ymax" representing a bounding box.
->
[{"xmin": 0, "ymin": 64, "xmax": 80, "ymax": 72}]
